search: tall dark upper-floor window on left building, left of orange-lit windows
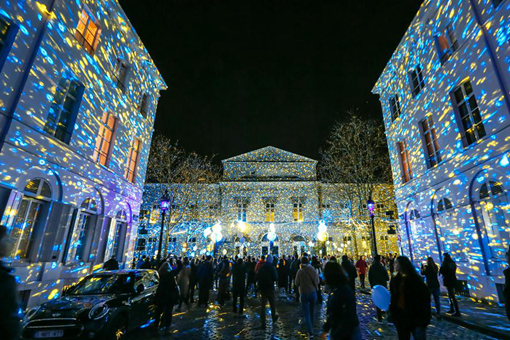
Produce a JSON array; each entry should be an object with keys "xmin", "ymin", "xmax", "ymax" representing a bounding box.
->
[{"xmin": 44, "ymin": 78, "xmax": 84, "ymax": 143}]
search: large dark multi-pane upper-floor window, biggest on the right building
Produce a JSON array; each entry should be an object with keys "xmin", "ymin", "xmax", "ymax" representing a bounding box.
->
[{"xmin": 453, "ymin": 80, "xmax": 485, "ymax": 146}]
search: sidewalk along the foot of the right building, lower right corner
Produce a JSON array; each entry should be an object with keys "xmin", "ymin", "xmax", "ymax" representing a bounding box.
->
[{"xmin": 438, "ymin": 296, "xmax": 510, "ymax": 339}]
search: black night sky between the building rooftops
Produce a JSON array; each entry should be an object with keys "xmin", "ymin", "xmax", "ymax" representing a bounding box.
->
[{"xmin": 120, "ymin": 0, "xmax": 421, "ymax": 160}]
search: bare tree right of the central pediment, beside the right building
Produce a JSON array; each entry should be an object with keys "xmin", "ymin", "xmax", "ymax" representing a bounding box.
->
[{"xmin": 319, "ymin": 111, "xmax": 392, "ymax": 253}]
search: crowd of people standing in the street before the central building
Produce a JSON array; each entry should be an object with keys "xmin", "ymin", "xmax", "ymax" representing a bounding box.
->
[{"xmin": 130, "ymin": 247, "xmax": 510, "ymax": 340}]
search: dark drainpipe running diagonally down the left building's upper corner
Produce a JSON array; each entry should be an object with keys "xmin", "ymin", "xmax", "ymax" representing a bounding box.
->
[{"xmin": 0, "ymin": 0, "xmax": 56, "ymax": 152}]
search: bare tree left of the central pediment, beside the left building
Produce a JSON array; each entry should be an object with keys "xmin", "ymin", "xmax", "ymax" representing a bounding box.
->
[{"xmin": 147, "ymin": 135, "xmax": 220, "ymax": 256}]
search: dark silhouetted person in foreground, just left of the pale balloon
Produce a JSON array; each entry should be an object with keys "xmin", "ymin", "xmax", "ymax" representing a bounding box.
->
[{"xmin": 323, "ymin": 262, "xmax": 361, "ymax": 340}]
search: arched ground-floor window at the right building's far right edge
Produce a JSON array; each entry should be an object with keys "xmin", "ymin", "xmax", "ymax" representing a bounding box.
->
[{"xmin": 479, "ymin": 180, "xmax": 510, "ymax": 261}]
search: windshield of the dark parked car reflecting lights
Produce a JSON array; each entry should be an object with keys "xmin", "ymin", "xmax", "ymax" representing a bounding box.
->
[{"xmin": 69, "ymin": 275, "xmax": 133, "ymax": 295}]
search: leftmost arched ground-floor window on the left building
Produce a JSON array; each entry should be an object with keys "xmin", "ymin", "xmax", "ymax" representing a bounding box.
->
[{"xmin": 9, "ymin": 178, "xmax": 51, "ymax": 260}]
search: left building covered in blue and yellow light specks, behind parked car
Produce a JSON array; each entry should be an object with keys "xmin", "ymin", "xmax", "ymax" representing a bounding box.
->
[{"xmin": 0, "ymin": 0, "xmax": 166, "ymax": 306}]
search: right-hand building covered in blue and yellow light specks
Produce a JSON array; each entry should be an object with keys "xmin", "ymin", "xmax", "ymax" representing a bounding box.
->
[{"xmin": 373, "ymin": 0, "xmax": 510, "ymax": 301}]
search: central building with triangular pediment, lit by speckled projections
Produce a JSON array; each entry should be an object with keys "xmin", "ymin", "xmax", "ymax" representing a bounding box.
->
[{"xmin": 136, "ymin": 147, "xmax": 398, "ymax": 256}]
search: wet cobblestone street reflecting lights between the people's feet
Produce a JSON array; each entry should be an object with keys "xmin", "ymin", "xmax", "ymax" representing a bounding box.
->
[{"xmin": 129, "ymin": 293, "xmax": 493, "ymax": 340}]
